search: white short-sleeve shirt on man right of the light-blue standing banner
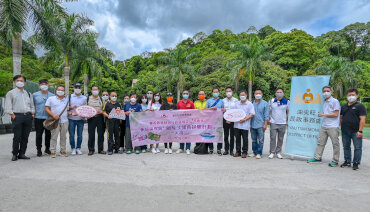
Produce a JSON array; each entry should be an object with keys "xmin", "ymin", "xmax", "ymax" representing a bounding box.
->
[{"xmin": 322, "ymin": 96, "xmax": 340, "ymax": 128}]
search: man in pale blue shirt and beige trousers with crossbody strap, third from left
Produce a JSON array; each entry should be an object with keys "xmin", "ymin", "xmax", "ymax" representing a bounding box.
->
[{"xmin": 45, "ymin": 85, "xmax": 69, "ymax": 158}]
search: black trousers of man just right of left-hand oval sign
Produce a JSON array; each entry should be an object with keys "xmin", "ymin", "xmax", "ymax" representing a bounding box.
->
[{"xmin": 87, "ymin": 114, "xmax": 104, "ymax": 152}]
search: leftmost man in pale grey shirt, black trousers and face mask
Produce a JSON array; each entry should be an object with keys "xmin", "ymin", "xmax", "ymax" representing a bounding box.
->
[{"xmin": 5, "ymin": 75, "xmax": 35, "ymax": 161}]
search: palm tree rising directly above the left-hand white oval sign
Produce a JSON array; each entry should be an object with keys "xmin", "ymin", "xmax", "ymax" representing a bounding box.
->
[{"xmin": 71, "ymin": 32, "xmax": 114, "ymax": 96}]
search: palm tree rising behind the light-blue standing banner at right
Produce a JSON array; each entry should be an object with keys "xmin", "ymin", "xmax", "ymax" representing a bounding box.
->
[{"xmin": 316, "ymin": 56, "xmax": 359, "ymax": 98}]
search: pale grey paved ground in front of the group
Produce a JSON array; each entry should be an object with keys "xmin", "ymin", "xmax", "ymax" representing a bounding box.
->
[{"xmin": 0, "ymin": 125, "xmax": 370, "ymax": 211}]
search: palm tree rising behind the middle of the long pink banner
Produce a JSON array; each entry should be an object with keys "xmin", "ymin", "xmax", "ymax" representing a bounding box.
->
[{"xmin": 159, "ymin": 45, "xmax": 197, "ymax": 101}]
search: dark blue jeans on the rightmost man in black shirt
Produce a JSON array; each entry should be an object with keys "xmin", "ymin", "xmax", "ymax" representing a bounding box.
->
[{"xmin": 342, "ymin": 130, "xmax": 362, "ymax": 164}]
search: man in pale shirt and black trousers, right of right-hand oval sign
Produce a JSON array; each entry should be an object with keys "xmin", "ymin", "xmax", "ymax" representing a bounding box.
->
[{"xmin": 234, "ymin": 91, "xmax": 255, "ymax": 158}]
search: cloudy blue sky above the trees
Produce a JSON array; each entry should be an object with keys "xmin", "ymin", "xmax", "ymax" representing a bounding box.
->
[{"xmin": 64, "ymin": 0, "xmax": 370, "ymax": 60}]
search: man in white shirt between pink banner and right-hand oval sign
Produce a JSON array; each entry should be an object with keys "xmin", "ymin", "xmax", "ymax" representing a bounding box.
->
[{"xmin": 222, "ymin": 87, "xmax": 239, "ymax": 156}]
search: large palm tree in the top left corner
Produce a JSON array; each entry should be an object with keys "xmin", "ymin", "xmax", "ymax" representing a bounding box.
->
[{"xmin": 0, "ymin": 0, "xmax": 70, "ymax": 78}]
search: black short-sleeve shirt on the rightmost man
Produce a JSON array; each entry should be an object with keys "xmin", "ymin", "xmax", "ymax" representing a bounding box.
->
[{"xmin": 340, "ymin": 102, "xmax": 367, "ymax": 132}]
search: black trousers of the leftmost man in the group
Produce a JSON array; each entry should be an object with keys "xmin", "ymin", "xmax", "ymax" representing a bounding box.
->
[{"xmin": 12, "ymin": 113, "xmax": 33, "ymax": 155}]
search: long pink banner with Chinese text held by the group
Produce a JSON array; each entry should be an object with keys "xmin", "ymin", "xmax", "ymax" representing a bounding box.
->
[{"xmin": 130, "ymin": 110, "xmax": 223, "ymax": 146}]
